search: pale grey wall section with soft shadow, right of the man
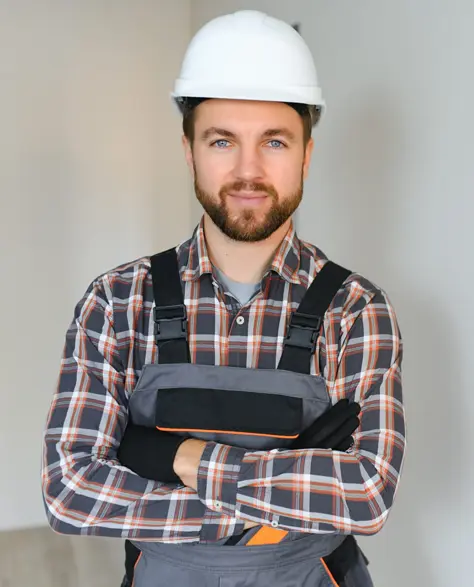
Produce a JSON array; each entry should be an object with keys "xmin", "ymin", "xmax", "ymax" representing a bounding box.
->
[{"xmin": 192, "ymin": 0, "xmax": 474, "ymax": 587}]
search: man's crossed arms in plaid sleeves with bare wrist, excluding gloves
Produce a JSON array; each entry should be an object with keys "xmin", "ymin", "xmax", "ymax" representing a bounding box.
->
[{"xmin": 42, "ymin": 284, "xmax": 405, "ymax": 542}]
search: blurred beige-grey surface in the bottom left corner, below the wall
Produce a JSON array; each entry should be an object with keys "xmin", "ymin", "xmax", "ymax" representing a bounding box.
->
[{"xmin": 0, "ymin": 527, "xmax": 124, "ymax": 587}]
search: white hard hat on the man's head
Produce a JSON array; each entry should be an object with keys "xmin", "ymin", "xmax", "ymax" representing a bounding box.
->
[{"xmin": 172, "ymin": 10, "xmax": 325, "ymax": 124}]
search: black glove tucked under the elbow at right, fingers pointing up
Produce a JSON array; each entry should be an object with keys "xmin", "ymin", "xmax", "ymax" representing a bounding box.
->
[{"xmin": 290, "ymin": 399, "xmax": 360, "ymax": 452}]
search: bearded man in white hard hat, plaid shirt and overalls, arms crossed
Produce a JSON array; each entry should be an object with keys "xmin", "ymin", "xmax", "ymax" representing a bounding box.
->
[{"xmin": 43, "ymin": 11, "xmax": 405, "ymax": 587}]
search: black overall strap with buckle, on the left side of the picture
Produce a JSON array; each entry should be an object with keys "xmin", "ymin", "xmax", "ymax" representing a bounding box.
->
[{"xmin": 150, "ymin": 248, "xmax": 190, "ymax": 363}]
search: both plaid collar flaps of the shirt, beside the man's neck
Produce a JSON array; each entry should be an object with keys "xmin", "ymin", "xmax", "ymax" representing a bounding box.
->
[{"xmin": 181, "ymin": 217, "xmax": 301, "ymax": 284}]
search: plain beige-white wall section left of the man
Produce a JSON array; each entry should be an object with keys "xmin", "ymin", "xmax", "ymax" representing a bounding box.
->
[{"xmin": 0, "ymin": 0, "xmax": 191, "ymax": 530}]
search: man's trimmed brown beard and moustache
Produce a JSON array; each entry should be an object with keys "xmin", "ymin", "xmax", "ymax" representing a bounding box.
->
[{"xmin": 194, "ymin": 170, "xmax": 303, "ymax": 243}]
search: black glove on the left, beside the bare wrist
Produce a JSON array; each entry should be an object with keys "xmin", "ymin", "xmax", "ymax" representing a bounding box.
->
[{"xmin": 117, "ymin": 423, "xmax": 187, "ymax": 483}]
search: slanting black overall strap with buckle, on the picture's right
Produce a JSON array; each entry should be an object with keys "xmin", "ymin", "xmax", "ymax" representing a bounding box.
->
[{"xmin": 278, "ymin": 261, "xmax": 352, "ymax": 373}]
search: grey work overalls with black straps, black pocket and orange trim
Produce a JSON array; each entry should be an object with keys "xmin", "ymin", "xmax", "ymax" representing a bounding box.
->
[{"xmin": 125, "ymin": 249, "xmax": 373, "ymax": 587}]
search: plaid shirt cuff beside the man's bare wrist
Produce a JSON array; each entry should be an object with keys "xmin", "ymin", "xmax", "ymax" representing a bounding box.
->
[{"xmin": 197, "ymin": 442, "xmax": 246, "ymax": 517}]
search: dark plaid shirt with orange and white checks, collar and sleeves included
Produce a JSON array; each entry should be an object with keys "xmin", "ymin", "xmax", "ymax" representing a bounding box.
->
[{"xmin": 42, "ymin": 222, "xmax": 405, "ymax": 543}]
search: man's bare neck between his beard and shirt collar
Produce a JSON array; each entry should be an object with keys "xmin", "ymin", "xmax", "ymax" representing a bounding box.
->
[{"xmin": 204, "ymin": 214, "xmax": 291, "ymax": 283}]
